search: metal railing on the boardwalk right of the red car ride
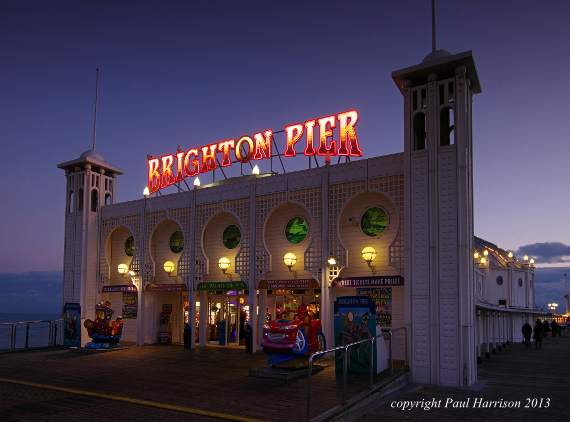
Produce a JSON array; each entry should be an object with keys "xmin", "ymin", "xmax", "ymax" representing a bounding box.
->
[{"xmin": 307, "ymin": 327, "xmax": 408, "ymax": 421}]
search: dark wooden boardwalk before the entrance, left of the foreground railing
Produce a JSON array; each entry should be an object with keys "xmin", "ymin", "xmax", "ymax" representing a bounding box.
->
[{"xmin": 0, "ymin": 345, "xmax": 400, "ymax": 422}]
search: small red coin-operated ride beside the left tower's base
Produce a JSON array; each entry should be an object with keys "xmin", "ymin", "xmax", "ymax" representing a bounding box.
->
[{"xmin": 83, "ymin": 301, "xmax": 123, "ymax": 349}]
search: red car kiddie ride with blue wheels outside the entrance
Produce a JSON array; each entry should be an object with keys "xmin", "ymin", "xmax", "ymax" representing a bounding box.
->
[{"xmin": 261, "ymin": 306, "xmax": 326, "ymax": 367}]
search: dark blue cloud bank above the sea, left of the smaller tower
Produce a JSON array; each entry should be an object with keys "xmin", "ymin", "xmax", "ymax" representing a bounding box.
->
[{"xmin": 0, "ymin": 271, "xmax": 63, "ymax": 314}]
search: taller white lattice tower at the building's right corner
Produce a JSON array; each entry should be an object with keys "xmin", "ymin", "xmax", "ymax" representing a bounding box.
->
[{"xmin": 392, "ymin": 50, "xmax": 481, "ymax": 387}]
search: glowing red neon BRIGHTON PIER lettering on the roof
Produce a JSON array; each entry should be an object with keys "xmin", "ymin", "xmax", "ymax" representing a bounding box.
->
[{"xmin": 148, "ymin": 110, "xmax": 362, "ymax": 194}]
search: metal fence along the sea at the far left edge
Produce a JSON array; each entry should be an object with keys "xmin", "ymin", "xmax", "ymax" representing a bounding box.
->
[{"xmin": 0, "ymin": 319, "xmax": 63, "ymax": 351}]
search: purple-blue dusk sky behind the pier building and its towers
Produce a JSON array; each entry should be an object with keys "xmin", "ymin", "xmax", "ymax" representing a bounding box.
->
[{"xmin": 0, "ymin": 0, "xmax": 570, "ymax": 312}]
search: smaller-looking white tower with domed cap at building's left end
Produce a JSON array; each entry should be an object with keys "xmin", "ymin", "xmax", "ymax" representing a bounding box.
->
[{"xmin": 58, "ymin": 149, "xmax": 123, "ymax": 332}]
